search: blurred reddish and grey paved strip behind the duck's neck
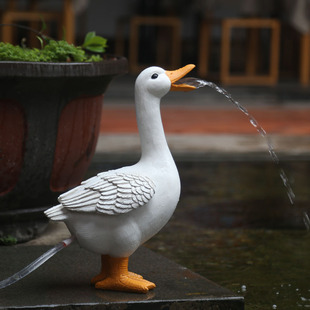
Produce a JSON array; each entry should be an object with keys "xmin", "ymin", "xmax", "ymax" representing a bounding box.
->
[{"xmin": 97, "ymin": 76, "xmax": 310, "ymax": 155}]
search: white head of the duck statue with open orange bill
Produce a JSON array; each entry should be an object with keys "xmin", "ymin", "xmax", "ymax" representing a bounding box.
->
[{"xmin": 136, "ymin": 65, "xmax": 196, "ymax": 98}]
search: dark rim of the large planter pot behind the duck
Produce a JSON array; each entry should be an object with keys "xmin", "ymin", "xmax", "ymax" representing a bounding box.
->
[{"xmin": 0, "ymin": 56, "xmax": 128, "ymax": 78}]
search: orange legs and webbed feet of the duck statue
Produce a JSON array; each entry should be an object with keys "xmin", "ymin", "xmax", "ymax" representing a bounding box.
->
[{"xmin": 92, "ymin": 256, "xmax": 156, "ymax": 293}]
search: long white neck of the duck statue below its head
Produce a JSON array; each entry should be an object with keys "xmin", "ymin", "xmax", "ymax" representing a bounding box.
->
[{"xmin": 135, "ymin": 92, "xmax": 173, "ymax": 164}]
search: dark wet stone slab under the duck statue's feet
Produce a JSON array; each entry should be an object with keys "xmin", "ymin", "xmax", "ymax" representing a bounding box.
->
[{"xmin": 0, "ymin": 244, "xmax": 244, "ymax": 310}]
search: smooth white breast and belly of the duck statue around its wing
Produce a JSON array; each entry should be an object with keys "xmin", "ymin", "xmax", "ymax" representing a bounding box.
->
[{"xmin": 65, "ymin": 164, "xmax": 180, "ymax": 257}]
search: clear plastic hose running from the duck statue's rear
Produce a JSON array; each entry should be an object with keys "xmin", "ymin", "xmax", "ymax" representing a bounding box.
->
[{"xmin": 0, "ymin": 236, "xmax": 75, "ymax": 289}]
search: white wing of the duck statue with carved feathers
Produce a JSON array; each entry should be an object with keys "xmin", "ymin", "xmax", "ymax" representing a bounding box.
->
[{"xmin": 59, "ymin": 172, "xmax": 155, "ymax": 215}]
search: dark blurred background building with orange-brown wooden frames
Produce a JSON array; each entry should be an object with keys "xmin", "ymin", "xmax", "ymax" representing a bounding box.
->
[{"xmin": 0, "ymin": 0, "xmax": 310, "ymax": 85}]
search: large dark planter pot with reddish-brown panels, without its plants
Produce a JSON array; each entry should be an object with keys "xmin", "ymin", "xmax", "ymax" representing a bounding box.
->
[{"xmin": 0, "ymin": 58, "xmax": 127, "ymax": 241}]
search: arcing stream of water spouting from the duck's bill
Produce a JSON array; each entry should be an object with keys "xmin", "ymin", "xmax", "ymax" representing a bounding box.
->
[{"xmin": 178, "ymin": 77, "xmax": 310, "ymax": 230}]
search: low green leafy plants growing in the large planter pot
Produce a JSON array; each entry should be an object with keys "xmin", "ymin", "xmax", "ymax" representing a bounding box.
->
[{"xmin": 0, "ymin": 32, "xmax": 107, "ymax": 62}]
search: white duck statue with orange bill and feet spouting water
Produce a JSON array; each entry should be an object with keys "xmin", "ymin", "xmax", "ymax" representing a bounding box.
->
[{"xmin": 45, "ymin": 65, "xmax": 195, "ymax": 293}]
